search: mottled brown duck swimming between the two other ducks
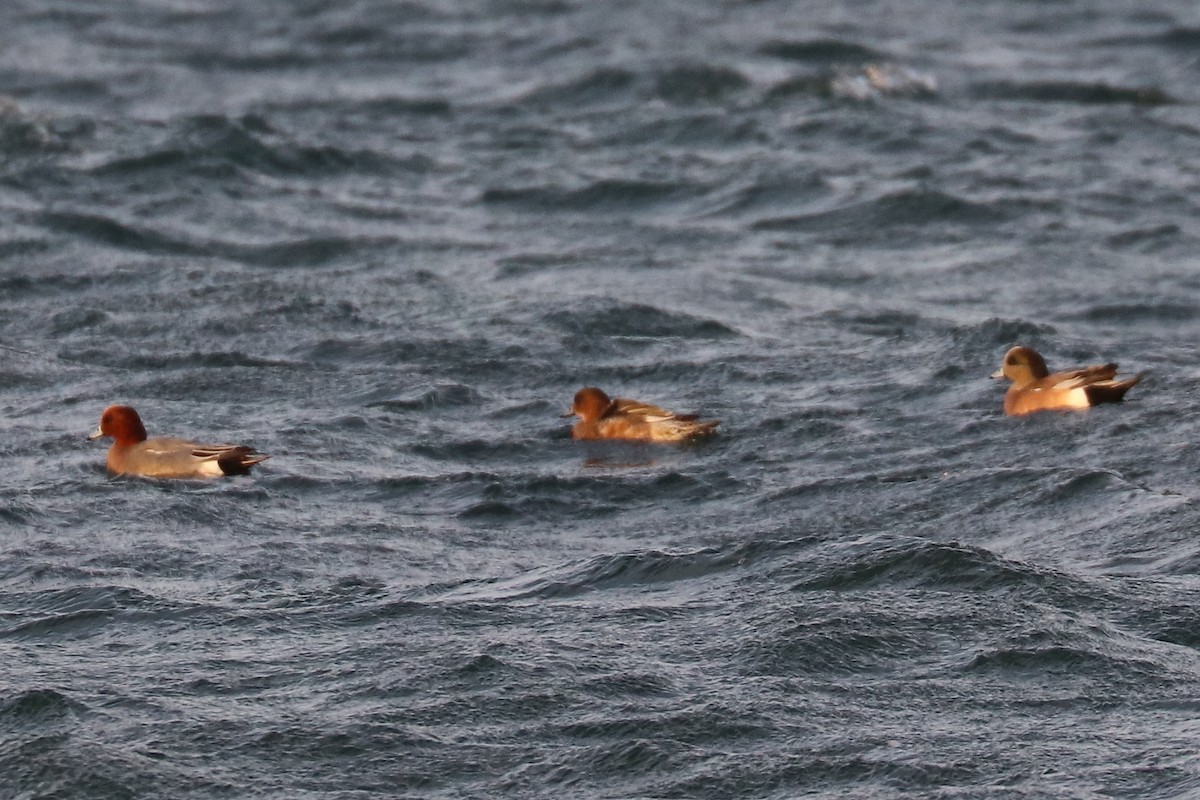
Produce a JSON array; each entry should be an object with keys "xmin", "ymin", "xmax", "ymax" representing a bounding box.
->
[{"xmin": 563, "ymin": 386, "xmax": 720, "ymax": 441}]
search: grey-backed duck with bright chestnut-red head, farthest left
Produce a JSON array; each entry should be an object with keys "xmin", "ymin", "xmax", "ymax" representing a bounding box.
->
[{"xmin": 88, "ymin": 405, "xmax": 270, "ymax": 479}]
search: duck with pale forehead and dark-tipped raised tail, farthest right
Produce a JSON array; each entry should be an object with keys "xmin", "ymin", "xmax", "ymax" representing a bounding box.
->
[{"xmin": 991, "ymin": 345, "xmax": 1144, "ymax": 416}]
